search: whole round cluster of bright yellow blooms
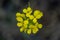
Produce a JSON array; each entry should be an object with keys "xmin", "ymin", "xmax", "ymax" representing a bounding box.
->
[{"xmin": 16, "ymin": 7, "xmax": 43, "ymax": 34}]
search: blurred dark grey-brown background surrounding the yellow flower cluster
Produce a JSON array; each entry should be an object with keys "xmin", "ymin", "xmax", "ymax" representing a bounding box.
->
[{"xmin": 0, "ymin": 0, "xmax": 60, "ymax": 40}]
